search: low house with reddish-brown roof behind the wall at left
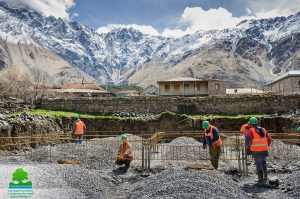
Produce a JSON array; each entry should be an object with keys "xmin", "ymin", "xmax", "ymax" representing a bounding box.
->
[{"xmin": 52, "ymin": 83, "xmax": 116, "ymax": 97}]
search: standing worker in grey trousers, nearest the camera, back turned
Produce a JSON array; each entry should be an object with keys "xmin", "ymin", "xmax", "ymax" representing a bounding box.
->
[{"xmin": 246, "ymin": 117, "xmax": 272, "ymax": 184}]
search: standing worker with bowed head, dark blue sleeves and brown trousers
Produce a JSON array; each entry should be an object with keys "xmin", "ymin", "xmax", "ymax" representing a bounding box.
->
[{"xmin": 202, "ymin": 121, "xmax": 222, "ymax": 169}]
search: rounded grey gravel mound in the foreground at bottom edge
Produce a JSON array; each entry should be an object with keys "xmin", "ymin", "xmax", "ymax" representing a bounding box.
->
[{"xmin": 128, "ymin": 168, "xmax": 249, "ymax": 199}]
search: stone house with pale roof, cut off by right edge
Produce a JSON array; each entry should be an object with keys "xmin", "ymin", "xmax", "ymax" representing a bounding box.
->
[{"xmin": 266, "ymin": 70, "xmax": 300, "ymax": 94}]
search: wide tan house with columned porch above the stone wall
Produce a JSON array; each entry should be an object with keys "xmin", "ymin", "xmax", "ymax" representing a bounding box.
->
[{"xmin": 157, "ymin": 77, "xmax": 226, "ymax": 97}]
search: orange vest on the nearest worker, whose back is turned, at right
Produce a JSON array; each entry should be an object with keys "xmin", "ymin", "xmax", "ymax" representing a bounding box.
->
[{"xmin": 250, "ymin": 127, "xmax": 269, "ymax": 152}]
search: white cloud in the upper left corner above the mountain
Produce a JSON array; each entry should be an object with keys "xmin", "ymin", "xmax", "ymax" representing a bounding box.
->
[{"xmin": 2, "ymin": 0, "xmax": 76, "ymax": 20}]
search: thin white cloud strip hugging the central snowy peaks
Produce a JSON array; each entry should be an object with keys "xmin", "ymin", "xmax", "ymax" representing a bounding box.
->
[{"xmin": 96, "ymin": 24, "xmax": 159, "ymax": 36}]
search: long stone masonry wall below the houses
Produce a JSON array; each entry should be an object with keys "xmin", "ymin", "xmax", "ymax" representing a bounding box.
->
[{"xmin": 37, "ymin": 94, "xmax": 300, "ymax": 115}]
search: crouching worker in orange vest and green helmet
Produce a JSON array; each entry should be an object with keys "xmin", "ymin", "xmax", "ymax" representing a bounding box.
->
[{"xmin": 116, "ymin": 135, "xmax": 133, "ymax": 170}]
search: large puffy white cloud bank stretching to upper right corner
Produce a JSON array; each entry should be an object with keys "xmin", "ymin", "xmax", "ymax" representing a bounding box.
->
[{"xmin": 161, "ymin": 3, "xmax": 300, "ymax": 37}]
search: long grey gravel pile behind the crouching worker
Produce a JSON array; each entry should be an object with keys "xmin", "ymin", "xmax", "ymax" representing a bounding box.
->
[{"xmin": 30, "ymin": 135, "xmax": 142, "ymax": 170}]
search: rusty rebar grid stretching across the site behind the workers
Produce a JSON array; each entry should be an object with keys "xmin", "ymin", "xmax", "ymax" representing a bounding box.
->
[{"xmin": 0, "ymin": 133, "xmax": 300, "ymax": 175}]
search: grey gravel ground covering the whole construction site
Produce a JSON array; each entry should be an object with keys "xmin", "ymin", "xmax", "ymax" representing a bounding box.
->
[{"xmin": 0, "ymin": 135, "xmax": 300, "ymax": 199}]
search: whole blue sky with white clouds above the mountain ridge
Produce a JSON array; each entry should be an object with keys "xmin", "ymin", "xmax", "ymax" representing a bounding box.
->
[{"xmin": 0, "ymin": 0, "xmax": 300, "ymax": 37}]
